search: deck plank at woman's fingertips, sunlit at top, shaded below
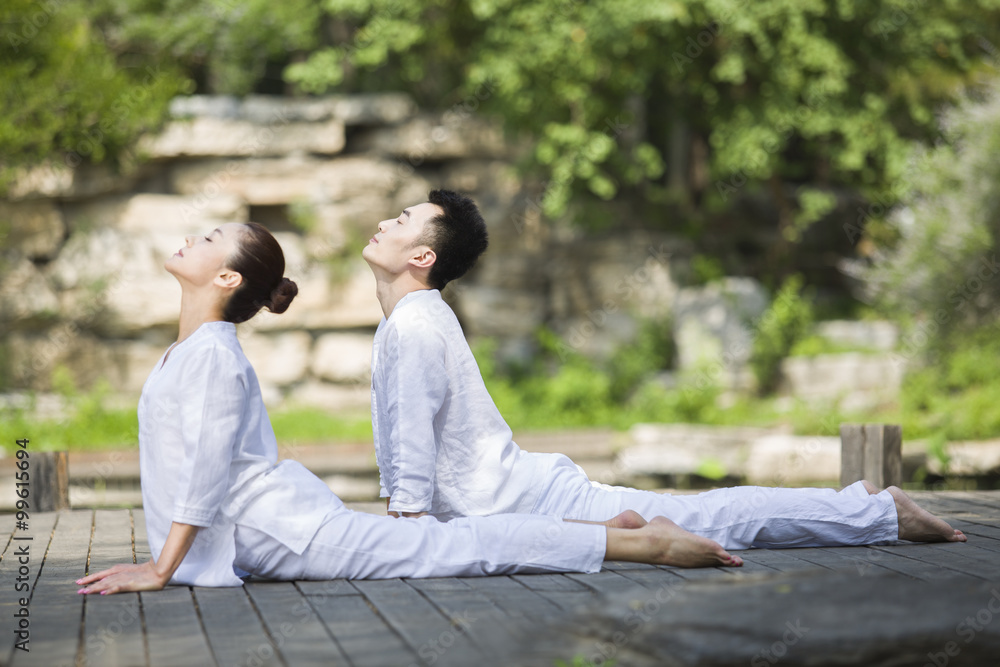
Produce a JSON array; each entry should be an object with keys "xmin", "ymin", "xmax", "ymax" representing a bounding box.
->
[{"xmin": 11, "ymin": 510, "xmax": 93, "ymax": 667}]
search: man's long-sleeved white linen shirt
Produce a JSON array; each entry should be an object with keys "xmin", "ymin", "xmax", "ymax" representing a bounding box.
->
[{"xmin": 372, "ymin": 289, "xmax": 560, "ymax": 521}]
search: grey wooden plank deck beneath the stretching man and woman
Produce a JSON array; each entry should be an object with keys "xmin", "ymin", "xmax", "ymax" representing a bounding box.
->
[{"xmin": 0, "ymin": 492, "xmax": 1000, "ymax": 667}]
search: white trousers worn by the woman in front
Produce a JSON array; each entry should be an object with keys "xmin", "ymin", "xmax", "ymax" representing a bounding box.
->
[{"xmin": 234, "ymin": 492, "xmax": 607, "ymax": 580}]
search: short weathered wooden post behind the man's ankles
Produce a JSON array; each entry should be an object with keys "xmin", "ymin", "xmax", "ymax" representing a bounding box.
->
[{"xmin": 840, "ymin": 424, "xmax": 903, "ymax": 488}]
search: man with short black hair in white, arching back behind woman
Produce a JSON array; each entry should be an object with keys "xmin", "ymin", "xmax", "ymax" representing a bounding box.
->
[{"xmin": 362, "ymin": 190, "xmax": 966, "ymax": 549}]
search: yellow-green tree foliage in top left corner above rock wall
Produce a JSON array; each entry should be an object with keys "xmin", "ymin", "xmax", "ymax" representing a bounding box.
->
[{"xmin": 0, "ymin": 0, "xmax": 188, "ymax": 194}]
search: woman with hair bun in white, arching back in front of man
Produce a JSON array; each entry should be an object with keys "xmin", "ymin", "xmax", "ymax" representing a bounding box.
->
[{"xmin": 77, "ymin": 223, "xmax": 742, "ymax": 594}]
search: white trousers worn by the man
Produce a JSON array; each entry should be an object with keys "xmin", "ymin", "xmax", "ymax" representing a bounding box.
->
[{"xmin": 532, "ymin": 458, "xmax": 899, "ymax": 549}]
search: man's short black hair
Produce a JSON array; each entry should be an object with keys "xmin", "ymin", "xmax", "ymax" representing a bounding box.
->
[{"xmin": 420, "ymin": 190, "xmax": 490, "ymax": 289}]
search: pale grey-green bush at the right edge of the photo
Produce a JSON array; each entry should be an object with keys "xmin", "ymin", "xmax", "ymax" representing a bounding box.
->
[{"xmin": 862, "ymin": 83, "xmax": 1000, "ymax": 350}]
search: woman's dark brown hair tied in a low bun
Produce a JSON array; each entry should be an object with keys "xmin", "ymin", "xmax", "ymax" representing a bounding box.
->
[{"xmin": 222, "ymin": 222, "xmax": 299, "ymax": 324}]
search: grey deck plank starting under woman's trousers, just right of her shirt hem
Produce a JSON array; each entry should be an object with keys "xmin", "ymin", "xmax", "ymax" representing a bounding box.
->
[{"xmin": 244, "ymin": 581, "xmax": 348, "ymax": 665}]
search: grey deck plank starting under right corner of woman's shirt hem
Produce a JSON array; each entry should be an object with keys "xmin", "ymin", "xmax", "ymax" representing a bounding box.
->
[{"xmin": 193, "ymin": 587, "xmax": 282, "ymax": 667}]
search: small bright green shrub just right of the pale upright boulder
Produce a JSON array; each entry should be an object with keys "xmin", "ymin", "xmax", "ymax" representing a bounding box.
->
[{"xmin": 750, "ymin": 276, "xmax": 813, "ymax": 393}]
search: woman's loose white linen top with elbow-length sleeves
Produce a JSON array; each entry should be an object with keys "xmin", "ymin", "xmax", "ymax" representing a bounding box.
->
[{"xmin": 138, "ymin": 322, "xmax": 330, "ymax": 586}]
